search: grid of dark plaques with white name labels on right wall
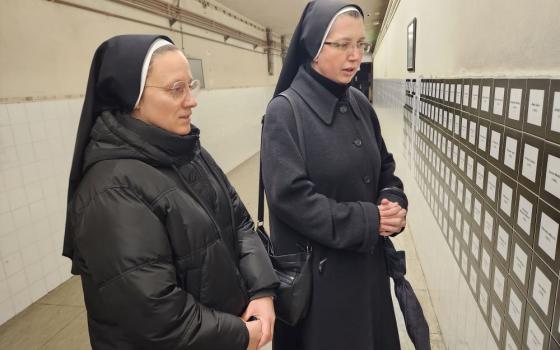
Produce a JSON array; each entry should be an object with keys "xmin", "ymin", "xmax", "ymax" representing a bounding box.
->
[{"xmin": 405, "ymin": 78, "xmax": 560, "ymax": 350}]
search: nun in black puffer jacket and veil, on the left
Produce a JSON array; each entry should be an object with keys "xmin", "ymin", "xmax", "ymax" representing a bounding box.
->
[{"xmin": 63, "ymin": 35, "xmax": 277, "ymax": 350}]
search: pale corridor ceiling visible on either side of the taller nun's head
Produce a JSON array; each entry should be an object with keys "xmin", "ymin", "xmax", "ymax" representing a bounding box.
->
[{"xmin": 217, "ymin": 0, "xmax": 389, "ymax": 42}]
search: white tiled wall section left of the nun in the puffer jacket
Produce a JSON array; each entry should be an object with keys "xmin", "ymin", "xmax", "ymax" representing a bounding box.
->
[{"xmin": 0, "ymin": 99, "xmax": 82, "ymax": 323}]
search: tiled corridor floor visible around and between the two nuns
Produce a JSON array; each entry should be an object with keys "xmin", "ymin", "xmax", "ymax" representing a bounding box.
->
[{"xmin": 0, "ymin": 152, "xmax": 445, "ymax": 350}]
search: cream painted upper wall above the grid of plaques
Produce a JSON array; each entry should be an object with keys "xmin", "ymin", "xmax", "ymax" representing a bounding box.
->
[{"xmin": 374, "ymin": 0, "xmax": 560, "ymax": 79}]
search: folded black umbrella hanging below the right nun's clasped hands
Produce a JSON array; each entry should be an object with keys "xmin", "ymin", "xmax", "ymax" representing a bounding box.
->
[{"xmin": 385, "ymin": 238, "xmax": 430, "ymax": 350}]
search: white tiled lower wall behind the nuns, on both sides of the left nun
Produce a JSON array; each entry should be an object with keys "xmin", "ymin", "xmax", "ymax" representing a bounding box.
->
[{"xmin": 0, "ymin": 86, "xmax": 273, "ymax": 324}]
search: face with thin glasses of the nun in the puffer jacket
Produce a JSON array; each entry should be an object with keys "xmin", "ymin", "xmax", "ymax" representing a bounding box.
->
[{"xmin": 133, "ymin": 50, "xmax": 197, "ymax": 135}]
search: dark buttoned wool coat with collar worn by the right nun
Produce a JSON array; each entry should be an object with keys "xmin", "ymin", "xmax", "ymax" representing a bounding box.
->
[{"xmin": 261, "ymin": 67, "xmax": 407, "ymax": 350}]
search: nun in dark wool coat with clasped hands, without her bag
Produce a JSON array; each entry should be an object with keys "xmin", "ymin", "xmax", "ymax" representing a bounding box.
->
[{"xmin": 261, "ymin": 0, "xmax": 408, "ymax": 350}]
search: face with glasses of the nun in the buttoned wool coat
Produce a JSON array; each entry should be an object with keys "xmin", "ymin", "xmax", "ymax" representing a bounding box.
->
[{"xmin": 313, "ymin": 15, "xmax": 365, "ymax": 84}]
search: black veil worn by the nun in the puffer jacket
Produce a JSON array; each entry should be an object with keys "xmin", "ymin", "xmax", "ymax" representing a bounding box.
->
[{"xmin": 62, "ymin": 35, "xmax": 172, "ymax": 258}]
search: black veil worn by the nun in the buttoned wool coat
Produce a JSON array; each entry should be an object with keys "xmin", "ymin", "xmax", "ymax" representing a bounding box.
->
[{"xmin": 274, "ymin": 0, "xmax": 363, "ymax": 96}]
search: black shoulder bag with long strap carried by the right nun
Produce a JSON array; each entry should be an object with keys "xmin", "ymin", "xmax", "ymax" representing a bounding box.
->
[{"xmin": 256, "ymin": 90, "xmax": 312, "ymax": 326}]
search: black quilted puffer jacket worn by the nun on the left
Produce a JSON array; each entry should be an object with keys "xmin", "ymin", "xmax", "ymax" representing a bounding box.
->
[{"xmin": 69, "ymin": 112, "xmax": 277, "ymax": 350}]
